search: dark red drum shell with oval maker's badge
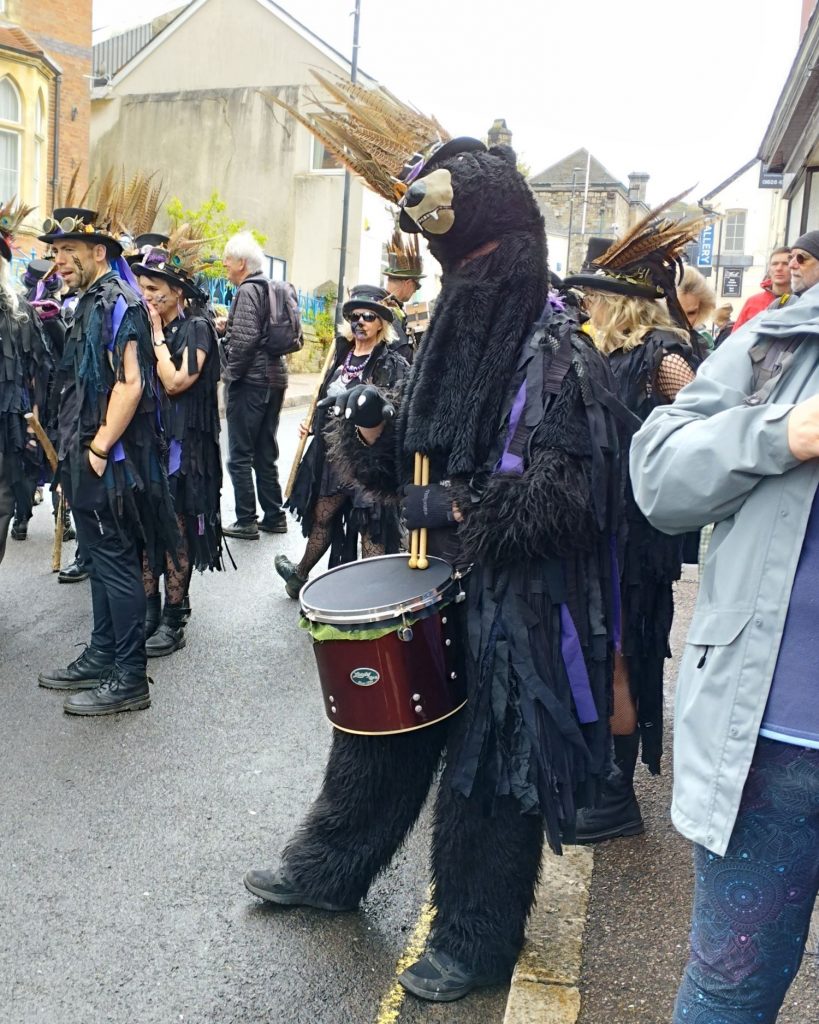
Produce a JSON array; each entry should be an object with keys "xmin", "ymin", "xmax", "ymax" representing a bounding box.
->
[{"xmin": 313, "ymin": 605, "xmax": 466, "ymax": 736}]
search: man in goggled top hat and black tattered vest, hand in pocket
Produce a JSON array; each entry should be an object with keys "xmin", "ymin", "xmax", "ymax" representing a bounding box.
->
[{"xmin": 39, "ymin": 199, "xmax": 177, "ymax": 715}]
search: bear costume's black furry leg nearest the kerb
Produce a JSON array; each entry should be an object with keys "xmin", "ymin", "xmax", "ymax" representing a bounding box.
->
[{"xmin": 429, "ymin": 757, "xmax": 544, "ymax": 977}]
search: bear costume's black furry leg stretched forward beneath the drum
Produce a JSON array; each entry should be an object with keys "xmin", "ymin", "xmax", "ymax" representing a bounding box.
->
[{"xmin": 282, "ymin": 722, "xmax": 447, "ymax": 905}]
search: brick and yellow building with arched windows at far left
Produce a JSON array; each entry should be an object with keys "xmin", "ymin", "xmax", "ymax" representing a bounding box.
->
[{"xmin": 0, "ymin": 0, "xmax": 92, "ymax": 253}]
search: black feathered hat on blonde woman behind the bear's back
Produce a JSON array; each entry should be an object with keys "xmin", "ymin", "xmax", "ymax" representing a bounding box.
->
[{"xmin": 563, "ymin": 188, "xmax": 710, "ymax": 326}]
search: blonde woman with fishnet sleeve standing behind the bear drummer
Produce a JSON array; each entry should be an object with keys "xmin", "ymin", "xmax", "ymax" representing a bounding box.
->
[{"xmin": 577, "ymin": 274, "xmax": 698, "ymax": 843}]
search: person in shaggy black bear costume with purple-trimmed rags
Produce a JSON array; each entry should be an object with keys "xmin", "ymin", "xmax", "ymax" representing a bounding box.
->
[{"xmin": 245, "ymin": 83, "xmax": 621, "ymax": 1000}]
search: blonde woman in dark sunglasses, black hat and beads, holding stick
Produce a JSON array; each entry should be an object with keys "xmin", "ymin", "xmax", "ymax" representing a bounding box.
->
[{"xmin": 274, "ymin": 285, "xmax": 410, "ymax": 599}]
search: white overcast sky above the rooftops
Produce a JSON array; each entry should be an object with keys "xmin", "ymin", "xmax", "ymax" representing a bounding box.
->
[{"xmin": 94, "ymin": 0, "xmax": 802, "ymax": 203}]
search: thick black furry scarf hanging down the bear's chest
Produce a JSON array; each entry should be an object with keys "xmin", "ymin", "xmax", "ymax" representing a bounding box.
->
[{"xmin": 399, "ymin": 233, "xmax": 549, "ymax": 476}]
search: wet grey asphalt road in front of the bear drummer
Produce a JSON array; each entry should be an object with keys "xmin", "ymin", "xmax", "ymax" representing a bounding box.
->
[{"xmin": 0, "ymin": 410, "xmax": 507, "ymax": 1024}]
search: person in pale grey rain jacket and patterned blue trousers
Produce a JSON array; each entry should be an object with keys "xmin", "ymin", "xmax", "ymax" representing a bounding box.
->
[{"xmin": 631, "ymin": 231, "xmax": 819, "ymax": 1024}]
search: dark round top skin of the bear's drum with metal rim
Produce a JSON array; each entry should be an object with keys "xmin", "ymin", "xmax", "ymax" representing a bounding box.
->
[{"xmin": 300, "ymin": 554, "xmax": 452, "ymax": 625}]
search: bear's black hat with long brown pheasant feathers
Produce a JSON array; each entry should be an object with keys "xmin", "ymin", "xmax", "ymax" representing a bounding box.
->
[{"xmin": 271, "ymin": 71, "xmax": 479, "ymax": 203}]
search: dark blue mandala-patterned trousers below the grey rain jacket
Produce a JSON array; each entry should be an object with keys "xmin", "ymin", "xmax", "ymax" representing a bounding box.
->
[{"xmin": 674, "ymin": 738, "xmax": 819, "ymax": 1024}]
